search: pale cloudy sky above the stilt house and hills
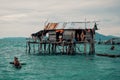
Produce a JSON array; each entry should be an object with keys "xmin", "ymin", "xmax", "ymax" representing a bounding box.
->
[{"xmin": 0, "ymin": 0, "xmax": 120, "ymax": 37}]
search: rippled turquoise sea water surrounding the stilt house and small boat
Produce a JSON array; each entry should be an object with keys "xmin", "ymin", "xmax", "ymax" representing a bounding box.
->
[{"xmin": 0, "ymin": 38, "xmax": 120, "ymax": 80}]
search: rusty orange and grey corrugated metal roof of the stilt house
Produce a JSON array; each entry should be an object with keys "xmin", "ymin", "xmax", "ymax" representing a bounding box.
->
[{"xmin": 44, "ymin": 22, "xmax": 94, "ymax": 30}]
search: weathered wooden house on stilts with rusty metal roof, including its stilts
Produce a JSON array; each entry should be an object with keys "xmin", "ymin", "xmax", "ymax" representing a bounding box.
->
[{"xmin": 26, "ymin": 22, "xmax": 97, "ymax": 55}]
